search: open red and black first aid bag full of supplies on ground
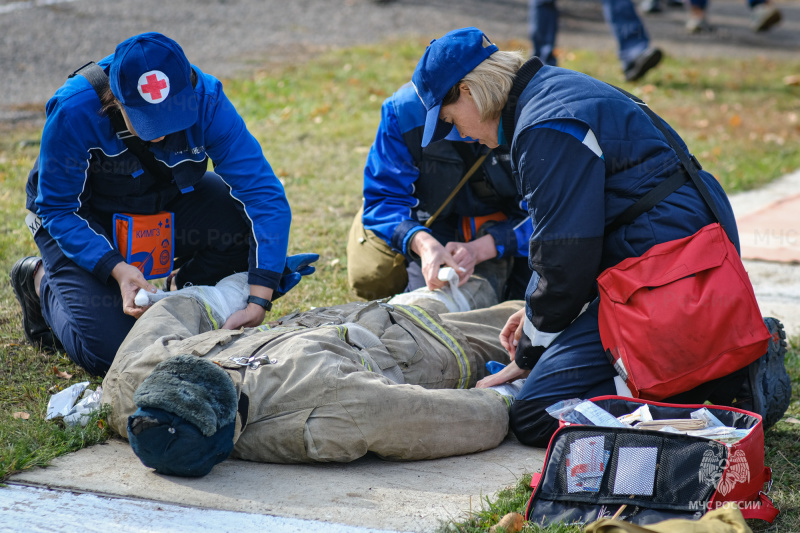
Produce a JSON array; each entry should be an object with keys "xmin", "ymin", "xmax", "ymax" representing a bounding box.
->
[{"xmin": 525, "ymin": 396, "xmax": 779, "ymax": 525}]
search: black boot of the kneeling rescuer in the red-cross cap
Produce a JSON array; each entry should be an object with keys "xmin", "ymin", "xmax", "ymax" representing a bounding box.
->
[{"xmin": 11, "ymin": 256, "xmax": 61, "ymax": 350}]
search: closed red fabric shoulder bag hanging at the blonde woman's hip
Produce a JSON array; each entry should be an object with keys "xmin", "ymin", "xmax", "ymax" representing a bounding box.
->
[{"xmin": 597, "ymin": 220, "xmax": 770, "ymax": 400}]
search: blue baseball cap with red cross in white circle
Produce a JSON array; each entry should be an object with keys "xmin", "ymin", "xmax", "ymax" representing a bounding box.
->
[{"xmin": 109, "ymin": 32, "xmax": 197, "ymax": 141}]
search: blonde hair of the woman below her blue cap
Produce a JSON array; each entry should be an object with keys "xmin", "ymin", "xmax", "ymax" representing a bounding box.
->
[{"xmin": 442, "ymin": 50, "xmax": 525, "ymax": 120}]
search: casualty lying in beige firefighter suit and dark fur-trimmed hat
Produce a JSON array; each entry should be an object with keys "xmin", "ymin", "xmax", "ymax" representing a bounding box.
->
[{"xmin": 103, "ymin": 274, "xmax": 523, "ymax": 476}]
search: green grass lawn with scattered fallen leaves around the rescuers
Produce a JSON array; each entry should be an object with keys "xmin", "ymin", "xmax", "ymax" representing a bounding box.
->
[{"xmin": 0, "ymin": 36, "xmax": 800, "ymax": 531}]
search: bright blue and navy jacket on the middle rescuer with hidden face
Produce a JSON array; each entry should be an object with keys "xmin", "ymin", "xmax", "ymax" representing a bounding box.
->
[{"xmin": 363, "ymin": 84, "xmax": 532, "ymax": 257}]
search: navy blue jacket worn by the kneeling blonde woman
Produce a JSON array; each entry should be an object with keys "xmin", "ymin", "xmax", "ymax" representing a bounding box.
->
[{"xmin": 502, "ymin": 58, "xmax": 739, "ymax": 347}]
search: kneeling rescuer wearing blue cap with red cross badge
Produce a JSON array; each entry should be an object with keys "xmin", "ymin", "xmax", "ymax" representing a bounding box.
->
[{"xmin": 11, "ymin": 33, "xmax": 291, "ymax": 374}]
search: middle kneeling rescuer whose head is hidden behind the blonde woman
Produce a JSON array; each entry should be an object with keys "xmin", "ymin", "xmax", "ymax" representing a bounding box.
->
[{"xmin": 348, "ymin": 84, "xmax": 532, "ymax": 300}]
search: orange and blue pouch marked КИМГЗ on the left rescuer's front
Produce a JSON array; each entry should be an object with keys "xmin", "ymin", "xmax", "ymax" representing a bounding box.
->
[{"xmin": 114, "ymin": 211, "xmax": 175, "ymax": 279}]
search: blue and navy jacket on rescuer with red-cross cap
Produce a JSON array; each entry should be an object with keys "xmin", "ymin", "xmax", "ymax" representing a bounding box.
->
[{"xmin": 26, "ymin": 56, "xmax": 291, "ymax": 288}]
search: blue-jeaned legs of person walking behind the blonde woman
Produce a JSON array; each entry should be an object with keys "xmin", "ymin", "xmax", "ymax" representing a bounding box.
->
[{"xmin": 528, "ymin": 0, "xmax": 663, "ymax": 81}]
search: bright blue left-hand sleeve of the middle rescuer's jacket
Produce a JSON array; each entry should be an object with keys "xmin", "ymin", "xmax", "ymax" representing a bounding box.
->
[{"xmin": 363, "ymin": 98, "xmax": 429, "ymax": 254}]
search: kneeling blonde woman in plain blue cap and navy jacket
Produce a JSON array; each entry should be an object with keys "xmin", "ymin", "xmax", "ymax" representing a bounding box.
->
[{"xmin": 412, "ymin": 28, "xmax": 791, "ymax": 446}]
